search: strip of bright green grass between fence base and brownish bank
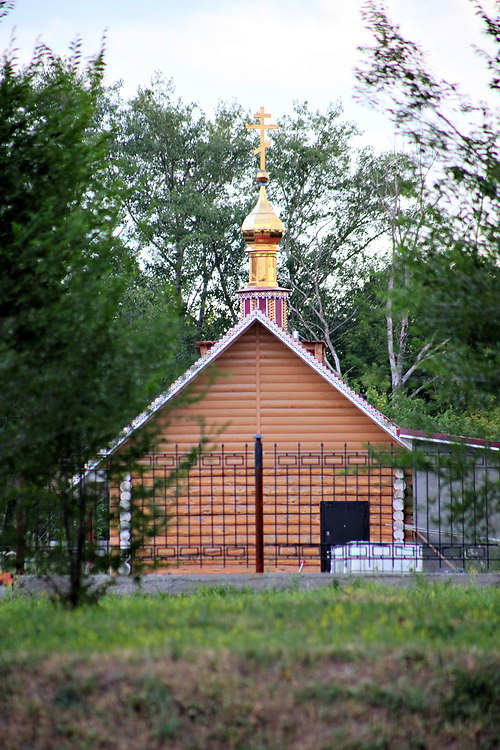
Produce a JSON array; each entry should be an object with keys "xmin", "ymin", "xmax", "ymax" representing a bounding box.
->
[{"xmin": 0, "ymin": 583, "xmax": 500, "ymax": 656}]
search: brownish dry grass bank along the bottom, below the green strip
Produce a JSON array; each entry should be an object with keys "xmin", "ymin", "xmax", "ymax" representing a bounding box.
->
[{"xmin": 0, "ymin": 649, "xmax": 500, "ymax": 750}]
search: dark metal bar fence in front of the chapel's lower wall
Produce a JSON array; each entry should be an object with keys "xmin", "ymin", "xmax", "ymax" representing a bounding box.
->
[{"xmin": 109, "ymin": 438, "xmax": 500, "ymax": 573}]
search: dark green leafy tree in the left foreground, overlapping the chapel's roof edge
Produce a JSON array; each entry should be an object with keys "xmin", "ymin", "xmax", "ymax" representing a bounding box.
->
[{"xmin": 0, "ymin": 30, "xmax": 182, "ymax": 606}]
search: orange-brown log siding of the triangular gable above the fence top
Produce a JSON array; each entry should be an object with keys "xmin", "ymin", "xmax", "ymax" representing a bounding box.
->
[{"xmin": 159, "ymin": 323, "xmax": 391, "ymax": 450}]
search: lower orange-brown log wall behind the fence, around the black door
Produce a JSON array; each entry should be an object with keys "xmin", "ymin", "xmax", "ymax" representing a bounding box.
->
[{"xmin": 117, "ymin": 454, "xmax": 393, "ymax": 572}]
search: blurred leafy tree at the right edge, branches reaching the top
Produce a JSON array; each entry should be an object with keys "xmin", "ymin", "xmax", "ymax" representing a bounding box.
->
[{"xmin": 357, "ymin": 2, "xmax": 500, "ymax": 434}]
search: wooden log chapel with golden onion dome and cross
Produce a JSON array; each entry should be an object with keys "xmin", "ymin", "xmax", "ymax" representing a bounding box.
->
[{"xmin": 103, "ymin": 108, "xmax": 411, "ymax": 573}]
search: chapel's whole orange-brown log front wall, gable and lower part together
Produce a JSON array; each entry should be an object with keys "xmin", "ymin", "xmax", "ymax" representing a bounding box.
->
[{"xmin": 114, "ymin": 323, "xmax": 402, "ymax": 573}]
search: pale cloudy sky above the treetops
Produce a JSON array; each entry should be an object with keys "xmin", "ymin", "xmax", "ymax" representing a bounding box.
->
[{"xmin": 0, "ymin": 0, "xmax": 496, "ymax": 149}]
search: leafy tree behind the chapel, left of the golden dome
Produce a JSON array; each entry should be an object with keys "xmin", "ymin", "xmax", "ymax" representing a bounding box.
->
[{"xmin": 111, "ymin": 78, "xmax": 251, "ymax": 346}]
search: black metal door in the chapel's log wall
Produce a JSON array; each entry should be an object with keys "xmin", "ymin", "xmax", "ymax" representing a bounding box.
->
[{"xmin": 320, "ymin": 500, "xmax": 370, "ymax": 572}]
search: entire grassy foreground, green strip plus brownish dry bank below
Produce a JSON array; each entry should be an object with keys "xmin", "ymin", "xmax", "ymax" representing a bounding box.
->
[{"xmin": 0, "ymin": 582, "xmax": 500, "ymax": 750}]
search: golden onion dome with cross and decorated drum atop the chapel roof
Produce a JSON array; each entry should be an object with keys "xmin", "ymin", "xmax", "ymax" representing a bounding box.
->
[{"xmin": 237, "ymin": 107, "xmax": 290, "ymax": 330}]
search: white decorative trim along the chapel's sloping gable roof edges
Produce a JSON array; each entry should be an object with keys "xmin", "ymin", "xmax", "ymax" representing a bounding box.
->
[{"xmin": 94, "ymin": 310, "xmax": 402, "ymax": 468}]
